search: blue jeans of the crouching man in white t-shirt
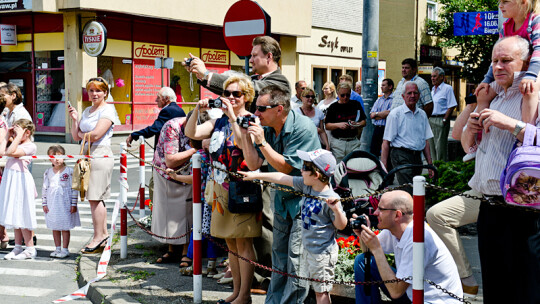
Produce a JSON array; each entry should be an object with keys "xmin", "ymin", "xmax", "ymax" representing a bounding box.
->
[{"xmin": 354, "ymin": 253, "xmax": 411, "ymax": 304}]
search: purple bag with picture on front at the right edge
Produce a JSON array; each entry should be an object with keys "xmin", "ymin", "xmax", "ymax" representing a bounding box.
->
[{"xmin": 501, "ymin": 124, "xmax": 540, "ymax": 209}]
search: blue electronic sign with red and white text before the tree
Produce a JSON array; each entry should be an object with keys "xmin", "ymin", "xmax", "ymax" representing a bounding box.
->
[{"xmin": 454, "ymin": 11, "xmax": 499, "ymax": 36}]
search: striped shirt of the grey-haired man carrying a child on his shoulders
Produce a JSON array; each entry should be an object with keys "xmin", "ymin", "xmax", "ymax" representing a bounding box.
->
[{"xmin": 469, "ymin": 72, "xmax": 525, "ymax": 195}]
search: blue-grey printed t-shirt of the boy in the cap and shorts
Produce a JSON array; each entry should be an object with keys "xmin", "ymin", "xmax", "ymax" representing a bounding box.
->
[{"xmin": 293, "ymin": 176, "xmax": 343, "ymax": 254}]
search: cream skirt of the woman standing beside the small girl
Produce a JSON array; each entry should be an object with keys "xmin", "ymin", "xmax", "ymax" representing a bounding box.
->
[{"xmin": 85, "ymin": 146, "xmax": 114, "ymax": 201}]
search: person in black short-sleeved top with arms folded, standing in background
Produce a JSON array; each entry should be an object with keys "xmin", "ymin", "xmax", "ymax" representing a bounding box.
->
[{"xmin": 325, "ymin": 81, "xmax": 366, "ymax": 163}]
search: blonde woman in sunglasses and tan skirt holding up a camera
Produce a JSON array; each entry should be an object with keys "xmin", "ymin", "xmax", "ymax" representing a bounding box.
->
[{"xmin": 185, "ymin": 74, "xmax": 262, "ymax": 304}]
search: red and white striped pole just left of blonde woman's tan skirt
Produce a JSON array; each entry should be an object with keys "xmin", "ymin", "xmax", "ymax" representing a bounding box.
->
[{"xmin": 192, "ymin": 153, "xmax": 202, "ymax": 303}]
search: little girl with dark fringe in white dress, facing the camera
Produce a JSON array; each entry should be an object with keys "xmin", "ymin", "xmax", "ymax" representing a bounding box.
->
[{"xmin": 41, "ymin": 145, "xmax": 81, "ymax": 259}]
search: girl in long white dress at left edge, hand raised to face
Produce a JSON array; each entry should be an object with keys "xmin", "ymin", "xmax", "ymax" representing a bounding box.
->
[{"xmin": 0, "ymin": 119, "xmax": 37, "ymax": 260}]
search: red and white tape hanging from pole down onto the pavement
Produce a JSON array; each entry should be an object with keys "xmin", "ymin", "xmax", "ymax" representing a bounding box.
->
[{"xmin": 53, "ymin": 200, "xmax": 120, "ymax": 303}]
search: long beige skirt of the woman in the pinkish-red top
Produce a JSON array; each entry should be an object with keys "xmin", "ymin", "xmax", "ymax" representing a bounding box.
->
[{"xmin": 152, "ymin": 170, "xmax": 193, "ymax": 245}]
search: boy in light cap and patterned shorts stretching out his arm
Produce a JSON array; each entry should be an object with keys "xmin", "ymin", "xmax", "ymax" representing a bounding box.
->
[{"xmin": 238, "ymin": 149, "xmax": 347, "ymax": 304}]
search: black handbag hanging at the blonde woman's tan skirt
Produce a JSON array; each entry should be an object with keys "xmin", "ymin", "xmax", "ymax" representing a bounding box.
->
[{"xmin": 228, "ymin": 152, "xmax": 263, "ymax": 213}]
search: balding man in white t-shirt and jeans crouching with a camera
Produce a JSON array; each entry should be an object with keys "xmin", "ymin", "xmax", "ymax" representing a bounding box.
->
[{"xmin": 351, "ymin": 190, "xmax": 463, "ymax": 304}]
